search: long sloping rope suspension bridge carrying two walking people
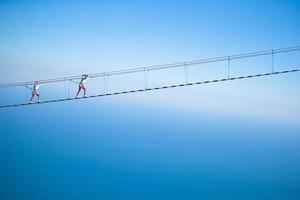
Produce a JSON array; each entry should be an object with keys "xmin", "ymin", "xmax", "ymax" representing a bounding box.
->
[{"xmin": 0, "ymin": 46, "xmax": 300, "ymax": 108}]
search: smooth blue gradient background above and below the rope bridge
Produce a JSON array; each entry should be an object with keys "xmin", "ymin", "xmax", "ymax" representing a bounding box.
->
[{"xmin": 0, "ymin": 0, "xmax": 300, "ymax": 200}]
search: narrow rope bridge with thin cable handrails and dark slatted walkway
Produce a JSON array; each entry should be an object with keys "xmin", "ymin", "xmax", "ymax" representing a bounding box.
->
[{"xmin": 0, "ymin": 46, "xmax": 300, "ymax": 108}]
